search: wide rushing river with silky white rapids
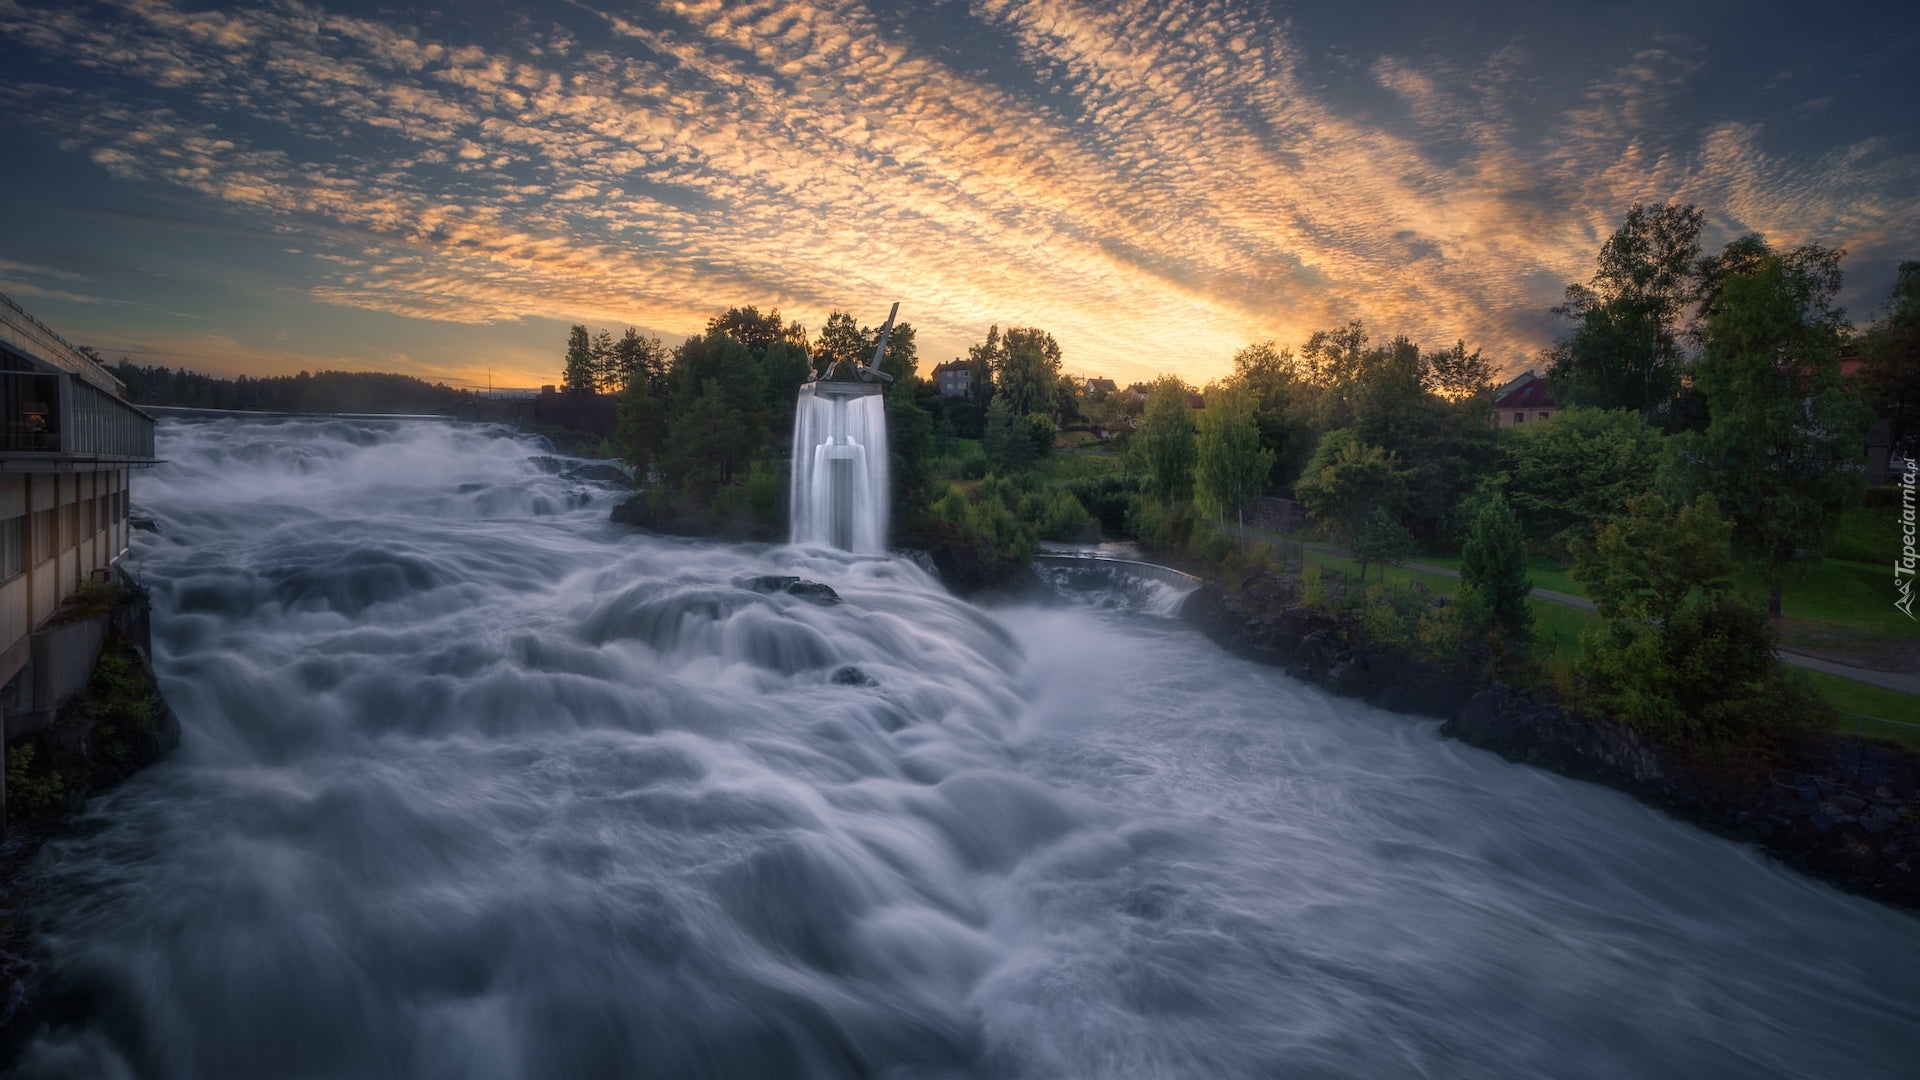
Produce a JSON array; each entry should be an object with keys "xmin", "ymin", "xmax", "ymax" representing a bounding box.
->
[{"xmin": 21, "ymin": 419, "xmax": 1920, "ymax": 1080}]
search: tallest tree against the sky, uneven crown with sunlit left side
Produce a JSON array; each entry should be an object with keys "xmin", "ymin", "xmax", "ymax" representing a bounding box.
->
[{"xmin": 1548, "ymin": 202, "xmax": 1703, "ymax": 421}]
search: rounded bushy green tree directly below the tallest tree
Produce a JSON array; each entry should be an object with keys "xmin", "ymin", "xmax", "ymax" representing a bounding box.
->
[{"xmin": 1500, "ymin": 407, "xmax": 1661, "ymax": 544}]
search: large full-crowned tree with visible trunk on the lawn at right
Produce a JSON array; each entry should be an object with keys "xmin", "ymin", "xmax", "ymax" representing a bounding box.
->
[{"xmin": 1690, "ymin": 238, "xmax": 1866, "ymax": 619}]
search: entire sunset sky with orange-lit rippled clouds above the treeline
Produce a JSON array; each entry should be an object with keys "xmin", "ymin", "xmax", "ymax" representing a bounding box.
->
[{"xmin": 0, "ymin": 0, "xmax": 1920, "ymax": 386}]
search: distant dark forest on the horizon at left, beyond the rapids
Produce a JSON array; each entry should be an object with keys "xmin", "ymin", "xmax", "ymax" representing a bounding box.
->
[{"xmin": 108, "ymin": 359, "xmax": 472, "ymax": 413}]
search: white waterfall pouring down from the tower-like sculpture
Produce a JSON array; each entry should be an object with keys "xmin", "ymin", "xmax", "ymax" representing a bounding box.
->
[{"xmin": 789, "ymin": 382, "xmax": 887, "ymax": 555}]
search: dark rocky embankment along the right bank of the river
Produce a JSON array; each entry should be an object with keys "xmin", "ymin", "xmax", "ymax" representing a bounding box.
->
[{"xmin": 1181, "ymin": 584, "xmax": 1920, "ymax": 909}]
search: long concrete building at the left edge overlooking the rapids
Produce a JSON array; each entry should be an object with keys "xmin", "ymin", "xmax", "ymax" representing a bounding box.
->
[{"xmin": 0, "ymin": 286, "xmax": 156, "ymax": 828}]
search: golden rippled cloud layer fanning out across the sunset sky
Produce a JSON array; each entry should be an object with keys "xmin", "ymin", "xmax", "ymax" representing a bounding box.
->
[{"xmin": 0, "ymin": 0, "xmax": 1920, "ymax": 380}]
